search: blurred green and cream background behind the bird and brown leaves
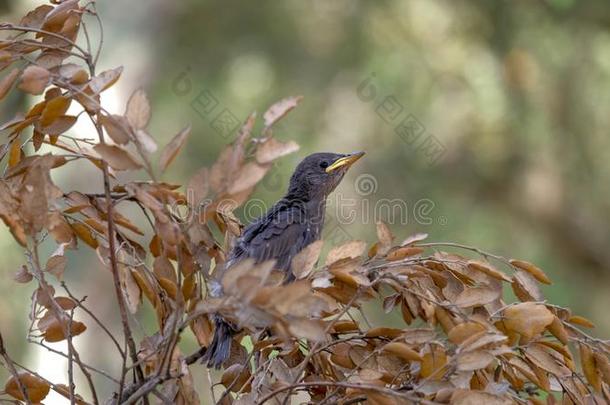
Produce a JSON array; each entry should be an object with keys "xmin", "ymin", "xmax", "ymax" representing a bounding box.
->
[{"xmin": 0, "ymin": 0, "xmax": 610, "ymax": 400}]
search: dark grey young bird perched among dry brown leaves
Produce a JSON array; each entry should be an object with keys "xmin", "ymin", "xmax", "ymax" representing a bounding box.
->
[{"xmin": 203, "ymin": 152, "xmax": 364, "ymax": 369}]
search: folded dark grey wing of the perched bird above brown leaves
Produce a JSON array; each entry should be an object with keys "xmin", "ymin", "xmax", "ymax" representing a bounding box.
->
[{"xmin": 230, "ymin": 205, "xmax": 308, "ymax": 270}]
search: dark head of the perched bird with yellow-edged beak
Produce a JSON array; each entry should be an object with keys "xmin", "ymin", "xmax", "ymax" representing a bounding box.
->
[{"xmin": 288, "ymin": 152, "xmax": 364, "ymax": 200}]
